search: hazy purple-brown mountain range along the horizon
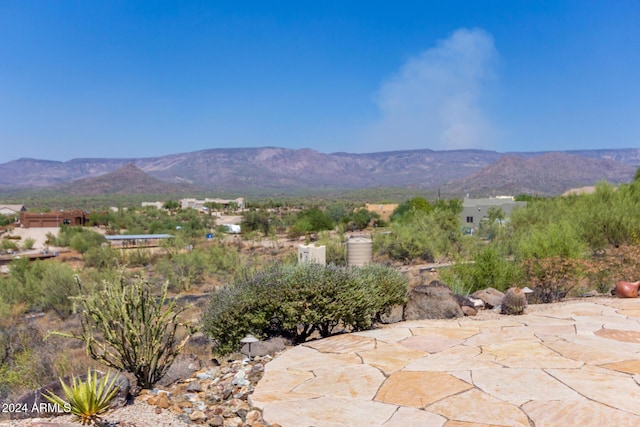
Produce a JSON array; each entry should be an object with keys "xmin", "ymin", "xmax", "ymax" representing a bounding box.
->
[{"xmin": 0, "ymin": 147, "xmax": 640, "ymax": 196}]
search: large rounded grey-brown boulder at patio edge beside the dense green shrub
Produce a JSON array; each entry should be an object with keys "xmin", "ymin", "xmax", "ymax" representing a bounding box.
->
[{"xmin": 404, "ymin": 280, "xmax": 464, "ymax": 320}]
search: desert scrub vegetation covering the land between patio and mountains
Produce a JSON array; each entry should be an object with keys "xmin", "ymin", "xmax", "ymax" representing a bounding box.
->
[{"xmin": 0, "ymin": 175, "xmax": 640, "ymax": 408}]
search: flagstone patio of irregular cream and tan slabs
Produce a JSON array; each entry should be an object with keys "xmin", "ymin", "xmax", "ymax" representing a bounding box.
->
[{"xmin": 250, "ymin": 298, "xmax": 640, "ymax": 427}]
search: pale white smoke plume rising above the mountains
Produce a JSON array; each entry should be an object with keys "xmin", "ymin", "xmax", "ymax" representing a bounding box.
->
[{"xmin": 362, "ymin": 29, "xmax": 499, "ymax": 152}]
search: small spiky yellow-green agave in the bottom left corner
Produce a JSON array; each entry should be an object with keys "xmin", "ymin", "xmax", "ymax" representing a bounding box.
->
[{"xmin": 44, "ymin": 371, "xmax": 118, "ymax": 425}]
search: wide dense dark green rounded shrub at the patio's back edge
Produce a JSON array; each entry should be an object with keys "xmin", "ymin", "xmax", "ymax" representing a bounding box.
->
[{"xmin": 203, "ymin": 263, "xmax": 407, "ymax": 353}]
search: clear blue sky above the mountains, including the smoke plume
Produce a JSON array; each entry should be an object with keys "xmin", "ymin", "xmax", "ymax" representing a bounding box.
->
[{"xmin": 0, "ymin": 0, "xmax": 640, "ymax": 162}]
